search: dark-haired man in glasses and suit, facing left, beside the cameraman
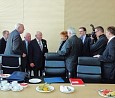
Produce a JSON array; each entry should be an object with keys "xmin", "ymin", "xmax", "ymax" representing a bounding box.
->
[{"xmin": 79, "ymin": 27, "xmax": 91, "ymax": 56}]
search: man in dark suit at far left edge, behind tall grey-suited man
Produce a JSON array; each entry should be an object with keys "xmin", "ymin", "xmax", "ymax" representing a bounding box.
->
[{"xmin": 0, "ymin": 30, "xmax": 9, "ymax": 54}]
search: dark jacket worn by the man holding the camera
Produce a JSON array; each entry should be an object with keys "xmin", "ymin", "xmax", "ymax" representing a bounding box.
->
[{"xmin": 90, "ymin": 34, "xmax": 108, "ymax": 56}]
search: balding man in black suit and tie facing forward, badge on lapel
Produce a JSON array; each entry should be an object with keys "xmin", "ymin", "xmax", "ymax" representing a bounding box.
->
[{"xmin": 29, "ymin": 31, "xmax": 48, "ymax": 76}]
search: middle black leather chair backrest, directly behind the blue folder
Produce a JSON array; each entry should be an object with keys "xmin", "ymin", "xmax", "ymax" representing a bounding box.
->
[{"xmin": 44, "ymin": 53, "xmax": 66, "ymax": 77}]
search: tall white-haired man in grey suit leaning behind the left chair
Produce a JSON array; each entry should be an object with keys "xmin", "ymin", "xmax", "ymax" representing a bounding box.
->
[{"xmin": 4, "ymin": 23, "xmax": 26, "ymax": 57}]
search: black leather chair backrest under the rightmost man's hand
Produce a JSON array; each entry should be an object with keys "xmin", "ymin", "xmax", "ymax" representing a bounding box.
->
[{"xmin": 77, "ymin": 57, "xmax": 101, "ymax": 83}]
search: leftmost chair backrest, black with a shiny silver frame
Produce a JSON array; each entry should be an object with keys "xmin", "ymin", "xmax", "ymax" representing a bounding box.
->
[{"xmin": 0, "ymin": 54, "xmax": 21, "ymax": 74}]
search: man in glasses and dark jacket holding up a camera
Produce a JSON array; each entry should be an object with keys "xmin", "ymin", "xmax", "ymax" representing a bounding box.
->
[{"xmin": 90, "ymin": 26, "xmax": 108, "ymax": 56}]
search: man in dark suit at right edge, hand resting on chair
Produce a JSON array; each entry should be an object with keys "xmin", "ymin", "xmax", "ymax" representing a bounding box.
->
[{"xmin": 95, "ymin": 26, "xmax": 115, "ymax": 83}]
